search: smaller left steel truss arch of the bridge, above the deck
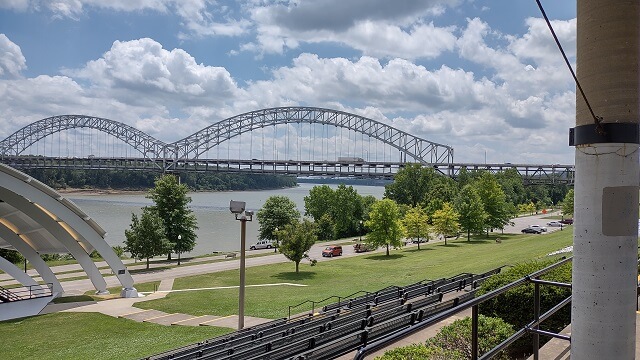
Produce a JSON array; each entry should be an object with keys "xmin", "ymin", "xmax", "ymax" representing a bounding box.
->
[{"xmin": 0, "ymin": 115, "xmax": 166, "ymax": 157}]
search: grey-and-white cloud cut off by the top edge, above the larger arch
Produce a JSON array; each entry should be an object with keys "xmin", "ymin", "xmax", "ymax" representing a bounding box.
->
[{"xmin": 242, "ymin": 0, "xmax": 459, "ymax": 59}]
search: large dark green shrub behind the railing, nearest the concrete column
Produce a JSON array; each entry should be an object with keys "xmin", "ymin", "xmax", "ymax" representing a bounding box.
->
[{"xmin": 477, "ymin": 259, "xmax": 571, "ymax": 355}]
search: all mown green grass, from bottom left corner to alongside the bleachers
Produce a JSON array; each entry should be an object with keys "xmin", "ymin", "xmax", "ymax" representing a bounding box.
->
[{"xmin": 0, "ymin": 227, "xmax": 572, "ymax": 359}]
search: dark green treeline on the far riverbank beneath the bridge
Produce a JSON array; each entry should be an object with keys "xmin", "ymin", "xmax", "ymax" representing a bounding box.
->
[{"xmin": 24, "ymin": 169, "xmax": 297, "ymax": 191}]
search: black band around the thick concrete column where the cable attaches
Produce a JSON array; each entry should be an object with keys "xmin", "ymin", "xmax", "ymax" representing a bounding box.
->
[{"xmin": 569, "ymin": 123, "xmax": 640, "ymax": 146}]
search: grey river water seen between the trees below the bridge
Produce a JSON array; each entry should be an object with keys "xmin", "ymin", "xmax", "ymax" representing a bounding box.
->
[{"xmin": 65, "ymin": 183, "xmax": 384, "ymax": 255}]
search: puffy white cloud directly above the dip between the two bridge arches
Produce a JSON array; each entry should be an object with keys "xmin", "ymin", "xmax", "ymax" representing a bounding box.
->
[{"xmin": 64, "ymin": 38, "xmax": 241, "ymax": 107}]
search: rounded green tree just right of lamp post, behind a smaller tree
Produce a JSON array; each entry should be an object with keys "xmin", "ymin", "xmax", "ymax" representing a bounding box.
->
[{"xmin": 256, "ymin": 195, "xmax": 300, "ymax": 240}]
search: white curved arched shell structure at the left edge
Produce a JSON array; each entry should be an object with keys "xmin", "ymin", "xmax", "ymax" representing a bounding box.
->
[{"xmin": 0, "ymin": 164, "xmax": 138, "ymax": 304}]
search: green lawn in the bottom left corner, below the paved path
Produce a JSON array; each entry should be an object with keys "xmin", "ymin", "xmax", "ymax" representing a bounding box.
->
[{"xmin": 0, "ymin": 312, "xmax": 230, "ymax": 360}]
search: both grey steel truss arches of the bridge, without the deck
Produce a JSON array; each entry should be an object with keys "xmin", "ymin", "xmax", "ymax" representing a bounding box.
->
[{"xmin": 0, "ymin": 107, "xmax": 453, "ymax": 164}]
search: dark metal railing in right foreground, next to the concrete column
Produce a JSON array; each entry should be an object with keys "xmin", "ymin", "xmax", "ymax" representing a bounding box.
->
[{"xmin": 354, "ymin": 257, "xmax": 573, "ymax": 360}]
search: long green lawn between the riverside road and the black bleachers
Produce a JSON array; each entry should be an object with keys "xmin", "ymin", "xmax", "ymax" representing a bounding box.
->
[{"xmin": 137, "ymin": 229, "xmax": 572, "ymax": 319}]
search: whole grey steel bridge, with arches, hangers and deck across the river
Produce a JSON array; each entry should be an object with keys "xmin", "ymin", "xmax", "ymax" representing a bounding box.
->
[{"xmin": 0, "ymin": 107, "xmax": 573, "ymax": 183}]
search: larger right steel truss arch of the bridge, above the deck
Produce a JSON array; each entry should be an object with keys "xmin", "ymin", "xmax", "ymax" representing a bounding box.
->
[{"xmin": 174, "ymin": 106, "xmax": 453, "ymax": 164}]
